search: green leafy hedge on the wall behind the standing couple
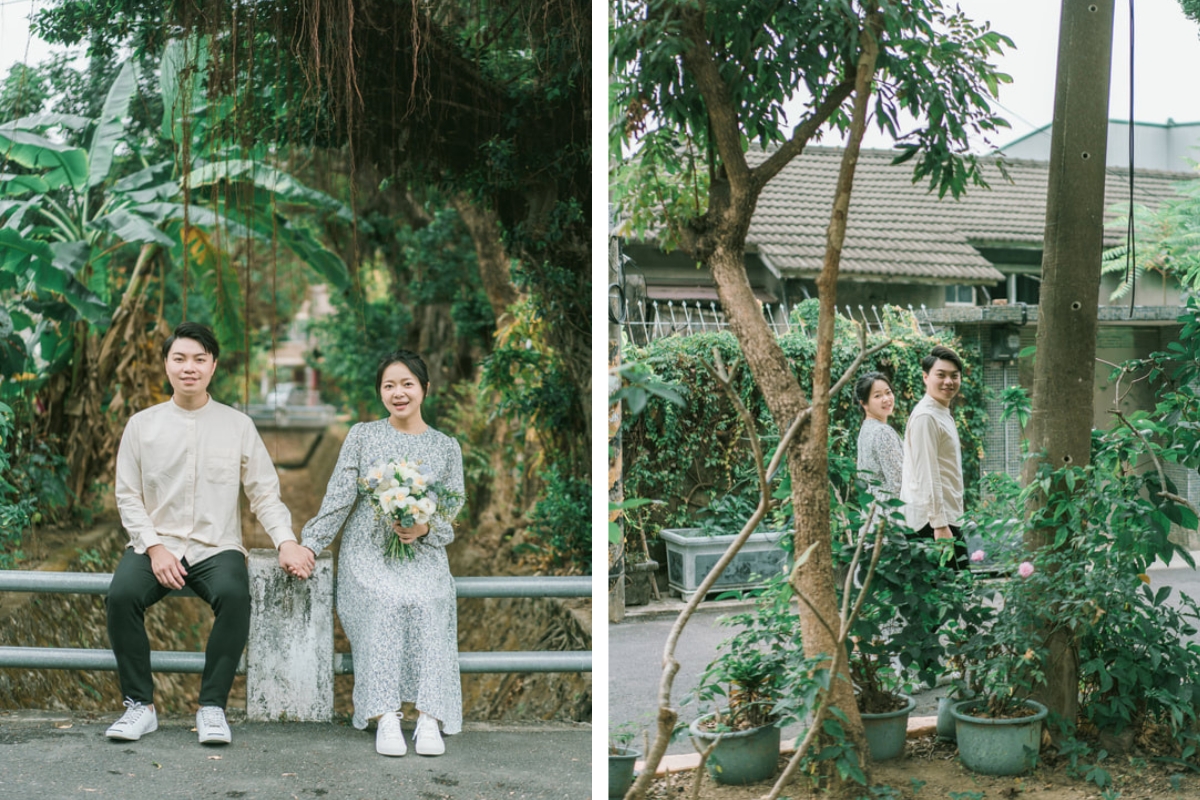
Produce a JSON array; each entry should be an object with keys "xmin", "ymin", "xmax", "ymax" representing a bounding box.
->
[{"xmin": 622, "ymin": 300, "xmax": 988, "ymax": 537}]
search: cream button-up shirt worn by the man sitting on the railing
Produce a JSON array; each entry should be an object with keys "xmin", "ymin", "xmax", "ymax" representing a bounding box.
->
[{"xmin": 116, "ymin": 397, "xmax": 296, "ymax": 564}]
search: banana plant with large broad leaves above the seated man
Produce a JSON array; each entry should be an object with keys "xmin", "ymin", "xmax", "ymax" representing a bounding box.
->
[{"xmin": 0, "ymin": 37, "xmax": 352, "ymax": 386}]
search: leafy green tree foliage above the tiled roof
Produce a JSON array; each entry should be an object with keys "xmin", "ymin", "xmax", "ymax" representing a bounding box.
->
[{"xmin": 610, "ymin": 0, "xmax": 1013, "ymax": 249}]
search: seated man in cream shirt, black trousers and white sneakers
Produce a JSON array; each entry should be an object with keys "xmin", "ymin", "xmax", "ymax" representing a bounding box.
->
[{"xmin": 106, "ymin": 323, "xmax": 313, "ymax": 744}]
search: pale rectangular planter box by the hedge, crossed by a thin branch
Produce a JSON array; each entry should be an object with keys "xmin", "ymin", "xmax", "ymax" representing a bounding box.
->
[{"xmin": 659, "ymin": 528, "xmax": 788, "ymax": 601}]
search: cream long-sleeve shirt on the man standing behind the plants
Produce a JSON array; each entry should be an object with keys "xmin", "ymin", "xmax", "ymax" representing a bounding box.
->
[{"xmin": 900, "ymin": 395, "xmax": 962, "ymax": 530}]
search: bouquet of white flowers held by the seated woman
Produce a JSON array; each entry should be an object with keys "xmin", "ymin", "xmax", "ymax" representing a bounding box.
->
[{"xmin": 359, "ymin": 461, "xmax": 460, "ymax": 560}]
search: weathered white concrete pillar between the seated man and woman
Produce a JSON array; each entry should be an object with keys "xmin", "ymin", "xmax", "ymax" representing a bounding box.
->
[{"xmin": 246, "ymin": 549, "xmax": 334, "ymax": 722}]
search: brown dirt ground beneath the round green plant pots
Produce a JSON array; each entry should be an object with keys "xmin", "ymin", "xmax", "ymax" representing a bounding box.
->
[{"xmin": 649, "ymin": 736, "xmax": 1200, "ymax": 800}]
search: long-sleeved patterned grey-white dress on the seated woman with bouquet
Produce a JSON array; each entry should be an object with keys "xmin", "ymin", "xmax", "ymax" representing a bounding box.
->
[{"xmin": 301, "ymin": 419, "xmax": 463, "ymax": 734}]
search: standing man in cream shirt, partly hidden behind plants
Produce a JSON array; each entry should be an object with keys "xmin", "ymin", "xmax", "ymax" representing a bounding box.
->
[{"xmin": 900, "ymin": 345, "xmax": 967, "ymax": 569}]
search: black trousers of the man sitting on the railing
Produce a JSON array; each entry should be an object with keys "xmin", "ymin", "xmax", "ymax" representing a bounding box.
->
[{"xmin": 104, "ymin": 548, "xmax": 250, "ymax": 709}]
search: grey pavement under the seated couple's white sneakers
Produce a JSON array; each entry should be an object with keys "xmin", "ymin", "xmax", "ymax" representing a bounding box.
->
[{"xmin": 0, "ymin": 711, "xmax": 592, "ymax": 800}]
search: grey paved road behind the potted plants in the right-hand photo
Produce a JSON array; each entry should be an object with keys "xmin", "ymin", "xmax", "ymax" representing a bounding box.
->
[{"xmin": 608, "ymin": 554, "xmax": 1200, "ymax": 753}]
